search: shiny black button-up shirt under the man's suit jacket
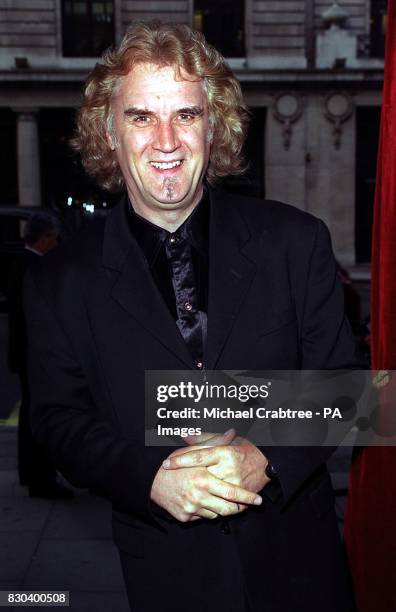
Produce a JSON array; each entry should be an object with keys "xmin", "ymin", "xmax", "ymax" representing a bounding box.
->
[{"xmin": 129, "ymin": 193, "xmax": 209, "ymax": 368}]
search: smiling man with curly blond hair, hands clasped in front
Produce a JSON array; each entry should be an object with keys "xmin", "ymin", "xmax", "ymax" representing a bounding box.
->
[{"xmin": 26, "ymin": 23, "xmax": 354, "ymax": 612}]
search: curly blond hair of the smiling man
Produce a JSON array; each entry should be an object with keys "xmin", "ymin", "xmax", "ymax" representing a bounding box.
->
[{"xmin": 72, "ymin": 21, "xmax": 249, "ymax": 191}]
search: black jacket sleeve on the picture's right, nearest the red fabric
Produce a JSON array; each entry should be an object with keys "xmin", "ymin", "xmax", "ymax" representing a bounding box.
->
[{"xmin": 260, "ymin": 220, "xmax": 366, "ymax": 504}]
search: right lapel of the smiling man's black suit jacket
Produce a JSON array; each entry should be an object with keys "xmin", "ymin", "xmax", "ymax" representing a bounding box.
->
[{"xmin": 205, "ymin": 190, "xmax": 257, "ymax": 369}]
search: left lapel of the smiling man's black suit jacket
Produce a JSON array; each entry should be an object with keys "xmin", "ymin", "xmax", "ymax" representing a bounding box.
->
[{"xmin": 103, "ymin": 198, "xmax": 194, "ymax": 368}]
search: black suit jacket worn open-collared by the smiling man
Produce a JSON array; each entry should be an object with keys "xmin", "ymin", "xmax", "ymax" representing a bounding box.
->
[{"xmin": 26, "ymin": 190, "xmax": 355, "ymax": 612}]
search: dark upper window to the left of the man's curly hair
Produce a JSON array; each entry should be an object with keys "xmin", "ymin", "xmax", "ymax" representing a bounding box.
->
[{"xmin": 62, "ymin": 0, "xmax": 114, "ymax": 57}]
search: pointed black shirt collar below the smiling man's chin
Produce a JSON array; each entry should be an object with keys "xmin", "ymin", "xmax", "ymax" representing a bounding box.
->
[{"xmin": 128, "ymin": 187, "xmax": 210, "ymax": 266}]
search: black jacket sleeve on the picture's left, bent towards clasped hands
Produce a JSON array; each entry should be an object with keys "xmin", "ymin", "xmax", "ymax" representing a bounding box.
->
[{"xmin": 24, "ymin": 273, "xmax": 169, "ymax": 521}]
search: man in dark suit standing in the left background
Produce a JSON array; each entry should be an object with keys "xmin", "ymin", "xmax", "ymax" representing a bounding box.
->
[{"xmin": 8, "ymin": 211, "xmax": 73, "ymax": 499}]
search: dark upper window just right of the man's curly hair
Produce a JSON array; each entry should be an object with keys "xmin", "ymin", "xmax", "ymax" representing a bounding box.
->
[{"xmin": 194, "ymin": 0, "xmax": 245, "ymax": 57}]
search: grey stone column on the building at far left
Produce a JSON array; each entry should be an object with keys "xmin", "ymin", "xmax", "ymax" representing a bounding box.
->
[{"xmin": 13, "ymin": 108, "xmax": 42, "ymax": 206}]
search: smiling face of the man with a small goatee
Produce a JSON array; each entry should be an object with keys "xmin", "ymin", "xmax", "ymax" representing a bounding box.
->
[{"xmin": 107, "ymin": 64, "xmax": 210, "ymax": 227}]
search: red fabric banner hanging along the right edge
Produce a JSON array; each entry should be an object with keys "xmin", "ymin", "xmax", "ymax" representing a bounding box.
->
[{"xmin": 345, "ymin": 0, "xmax": 396, "ymax": 612}]
